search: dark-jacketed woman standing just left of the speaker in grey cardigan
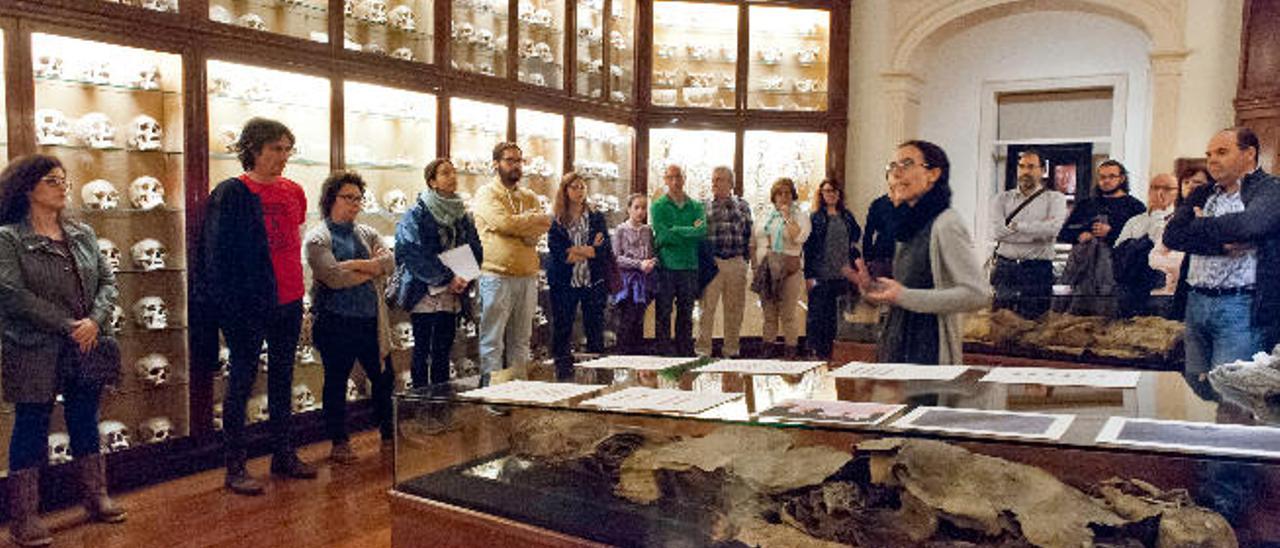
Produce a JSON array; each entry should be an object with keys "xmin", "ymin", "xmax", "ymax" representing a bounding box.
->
[{"xmin": 804, "ymin": 178, "xmax": 863, "ymax": 360}]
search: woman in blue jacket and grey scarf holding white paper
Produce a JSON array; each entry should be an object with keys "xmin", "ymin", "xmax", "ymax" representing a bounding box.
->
[{"xmin": 396, "ymin": 159, "xmax": 484, "ymax": 387}]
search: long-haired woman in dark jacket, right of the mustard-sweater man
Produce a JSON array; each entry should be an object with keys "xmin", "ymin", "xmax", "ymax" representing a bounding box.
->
[{"xmin": 547, "ymin": 172, "xmax": 613, "ymax": 380}]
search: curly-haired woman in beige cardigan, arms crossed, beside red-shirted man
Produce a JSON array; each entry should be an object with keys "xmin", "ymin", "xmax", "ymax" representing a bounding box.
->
[{"xmin": 303, "ymin": 172, "xmax": 394, "ymax": 463}]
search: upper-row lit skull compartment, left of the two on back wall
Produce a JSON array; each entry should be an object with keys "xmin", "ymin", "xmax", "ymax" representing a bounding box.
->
[{"xmin": 652, "ymin": 1, "xmax": 737, "ymax": 109}]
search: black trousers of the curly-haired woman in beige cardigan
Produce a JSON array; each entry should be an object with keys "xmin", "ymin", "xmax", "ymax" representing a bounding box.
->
[{"xmin": 312, "ymin": 312, "xmax": 396, "ymax": 443}]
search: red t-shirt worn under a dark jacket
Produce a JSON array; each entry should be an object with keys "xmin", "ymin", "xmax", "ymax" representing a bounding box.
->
[{"xmin": 241, "ymin": 174, "xmax": 307, "ymax": 305}]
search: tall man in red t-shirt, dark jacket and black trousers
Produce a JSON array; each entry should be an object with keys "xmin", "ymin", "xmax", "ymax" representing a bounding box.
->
[{"xmin": 192, "ymin": 118, "xmax": 316, "ymax": 494}]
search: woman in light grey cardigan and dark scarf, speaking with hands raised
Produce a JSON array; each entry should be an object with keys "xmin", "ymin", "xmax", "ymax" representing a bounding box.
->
[{"xmin": 845, "ymin": 141, "xmax": 991, "ymax": 364}]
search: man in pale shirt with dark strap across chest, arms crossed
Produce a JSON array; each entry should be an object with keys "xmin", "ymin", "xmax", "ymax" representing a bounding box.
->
[{"xmin": 991, "ymin": 150, "xmax": 1066, "ymax": 319}]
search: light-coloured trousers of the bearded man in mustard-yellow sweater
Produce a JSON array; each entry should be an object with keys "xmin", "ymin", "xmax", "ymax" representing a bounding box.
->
[{"xmin": 477, "ymin": 273, "xmax": 538, "ymax": 373}]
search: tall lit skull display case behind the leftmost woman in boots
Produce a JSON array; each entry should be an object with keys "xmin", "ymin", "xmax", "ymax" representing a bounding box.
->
[{"xmin": 31, "ymin": 33, "xmax": 189, "ymax": 457}]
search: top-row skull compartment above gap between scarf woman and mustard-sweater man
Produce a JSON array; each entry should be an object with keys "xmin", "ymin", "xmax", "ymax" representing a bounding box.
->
[{"xmin": 449, "ymin": 0, "xmax": 511, "ymax": 78}]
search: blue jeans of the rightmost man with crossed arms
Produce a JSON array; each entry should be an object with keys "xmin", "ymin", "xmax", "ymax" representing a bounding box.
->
[{"xmin": 1185, "ymin": 291, "xmax": 1262, "ymax": 382}]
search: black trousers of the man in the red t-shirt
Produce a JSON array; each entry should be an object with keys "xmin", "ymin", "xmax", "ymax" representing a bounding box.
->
[{"xmin": 219, "ymin": 300, "xmax": 302, "ymax": 458}]
